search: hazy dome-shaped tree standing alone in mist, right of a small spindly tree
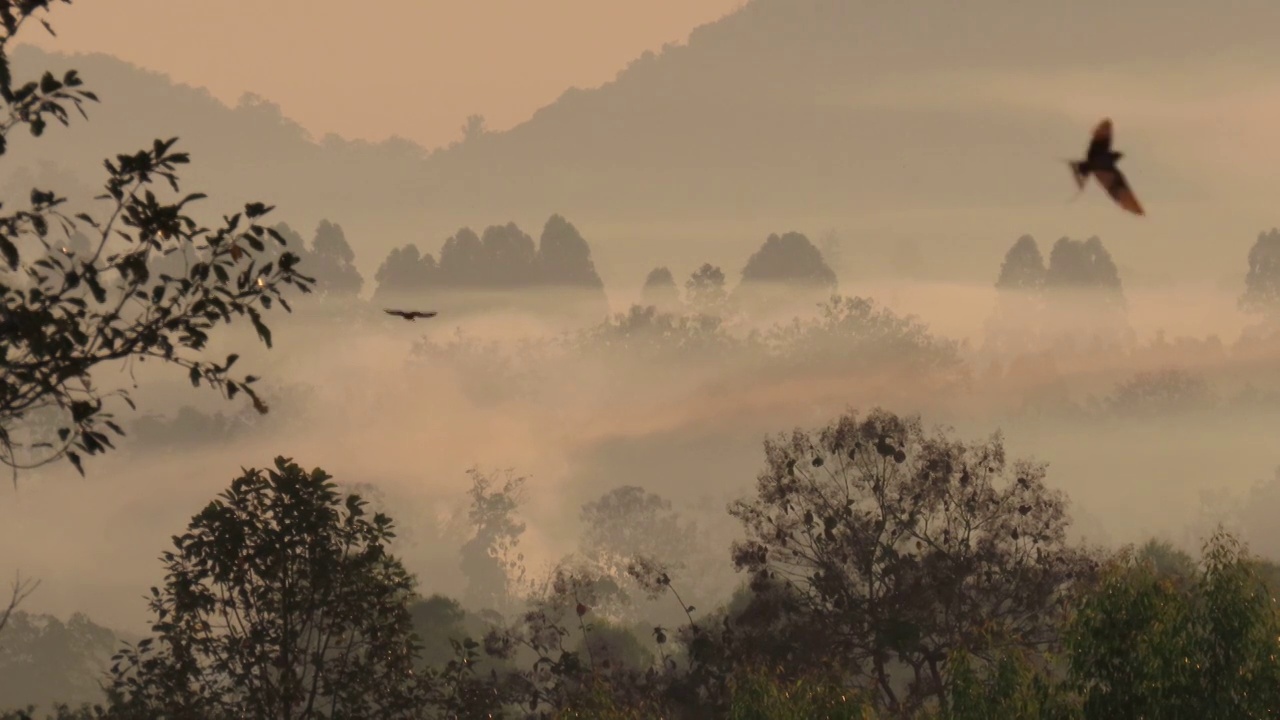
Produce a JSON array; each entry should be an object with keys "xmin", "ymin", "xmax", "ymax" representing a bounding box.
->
[{"xmin": 733, "ymin": 232, "xmax": 837, "ymax": 311}]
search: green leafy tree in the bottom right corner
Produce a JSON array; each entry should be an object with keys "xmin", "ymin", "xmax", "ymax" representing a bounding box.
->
[{"xmin": 1066, "ymin": 532, "xmax": 1280, "ymax": 720}]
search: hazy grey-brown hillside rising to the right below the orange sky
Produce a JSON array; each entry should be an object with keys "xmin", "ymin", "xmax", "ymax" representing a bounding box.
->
[{"xmin": 0, "ymin": 0, "xmax": 1280, "ymax": 291}]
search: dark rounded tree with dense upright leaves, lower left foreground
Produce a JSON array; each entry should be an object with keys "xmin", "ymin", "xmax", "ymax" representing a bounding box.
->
[{"xmin": 110, "ymin": 457, "xmax": 420, "ymax": 720}]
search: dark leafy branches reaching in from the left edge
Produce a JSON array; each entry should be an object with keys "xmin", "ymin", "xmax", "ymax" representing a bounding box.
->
[{"xmin": 0, "ymin": 0, "xmax": 311, "ymax": 478}]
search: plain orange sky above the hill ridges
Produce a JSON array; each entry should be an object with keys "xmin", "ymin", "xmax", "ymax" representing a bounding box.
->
[{"xmin": 22, "ymin": 0, "xmax": 742, "ymax": 147}]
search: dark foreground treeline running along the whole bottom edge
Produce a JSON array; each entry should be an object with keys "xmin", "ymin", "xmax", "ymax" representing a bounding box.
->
[{"xmin": 0, "ymin": 410, "xmax": 1280, "ymax": 720}]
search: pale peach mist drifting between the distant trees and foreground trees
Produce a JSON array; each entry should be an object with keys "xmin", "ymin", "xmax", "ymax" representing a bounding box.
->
[{"xmin": 0, "ymin": 275, "xmax": 1280, "ymax": 633}]
